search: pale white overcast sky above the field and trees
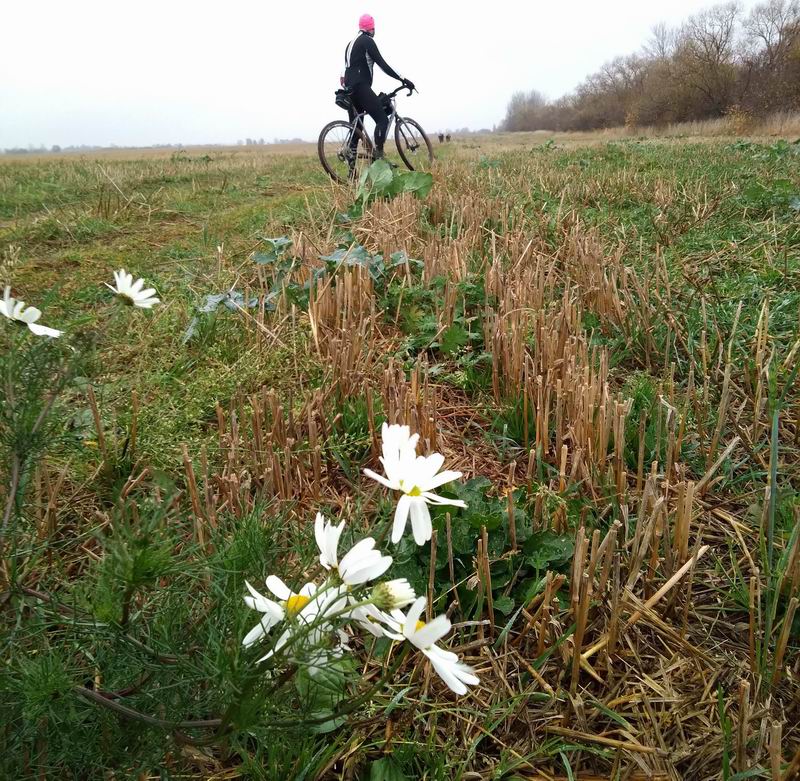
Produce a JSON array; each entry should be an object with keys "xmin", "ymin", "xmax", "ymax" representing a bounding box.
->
[{"xmin": 0, "ymin": 0, "xmax": 755, "ymax": 148}]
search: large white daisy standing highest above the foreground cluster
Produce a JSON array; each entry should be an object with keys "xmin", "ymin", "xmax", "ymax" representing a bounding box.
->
[{"xmin": 364, "ymin": 430, "xmax": 467, "ymax": 545}]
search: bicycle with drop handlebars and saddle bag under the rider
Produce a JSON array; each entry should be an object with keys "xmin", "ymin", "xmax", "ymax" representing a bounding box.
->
[{"xmin": 317, "ymin": 85, "xmax": 433, "ymax": 184}]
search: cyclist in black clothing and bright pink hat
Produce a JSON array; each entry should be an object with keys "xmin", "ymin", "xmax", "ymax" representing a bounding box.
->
[{"xmin": 342, "ymin": 14, "xmax": 414, "ymax": 168}]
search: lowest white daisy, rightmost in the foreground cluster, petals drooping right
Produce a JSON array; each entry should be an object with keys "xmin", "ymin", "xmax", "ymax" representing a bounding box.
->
[{"xmin": 386, "ymin": 597, "xmax": 480, "ymax": 694}]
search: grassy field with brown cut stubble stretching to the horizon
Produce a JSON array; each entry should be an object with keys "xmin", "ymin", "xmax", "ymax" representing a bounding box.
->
[{"xmin": 0, "ymin": 134, "xmax": 800, "ymax": 779}]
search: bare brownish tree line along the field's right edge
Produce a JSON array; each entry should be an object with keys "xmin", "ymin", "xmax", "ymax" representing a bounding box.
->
[{"xmin": 501, "ymin": 0, "xmax": 800, "ymax": 131}]
